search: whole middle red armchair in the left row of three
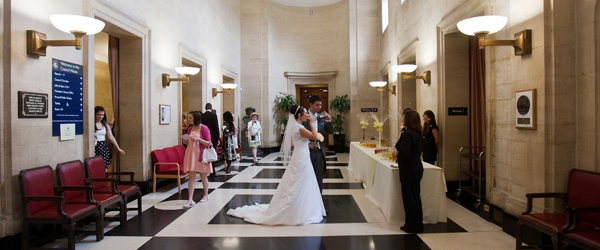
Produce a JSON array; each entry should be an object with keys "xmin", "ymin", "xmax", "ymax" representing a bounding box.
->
[{"xmin": 56, "ymin": 160, "xmax": 127, "ymax": 227}]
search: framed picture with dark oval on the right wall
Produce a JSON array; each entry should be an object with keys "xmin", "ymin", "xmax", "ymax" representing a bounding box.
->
[{"xmin": 515, "ymin": 89, "xmax": 537, "ymax": 129}]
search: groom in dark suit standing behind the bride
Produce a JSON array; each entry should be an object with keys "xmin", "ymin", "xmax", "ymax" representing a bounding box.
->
[{"xmin": 302, "ymin": 95, "xmax": 333, "ymax": 193}]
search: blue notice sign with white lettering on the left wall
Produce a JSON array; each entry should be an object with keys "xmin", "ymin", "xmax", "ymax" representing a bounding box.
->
[{"xmin": 52, "ymin": 58, "xmax": 83, "ymax": 136}]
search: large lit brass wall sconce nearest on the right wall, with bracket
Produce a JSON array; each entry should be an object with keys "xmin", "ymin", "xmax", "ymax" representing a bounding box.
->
[{"xmin": 456, "ymin": 16, "xmax": 531, "ymax": 56}]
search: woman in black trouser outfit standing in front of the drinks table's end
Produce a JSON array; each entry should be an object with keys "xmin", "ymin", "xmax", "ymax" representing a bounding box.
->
[{"xmin": 394, "ymin": 110, "xmax": 423, "ymax": 233}]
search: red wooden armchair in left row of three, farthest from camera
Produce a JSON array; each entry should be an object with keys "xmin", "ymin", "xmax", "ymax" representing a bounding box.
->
[{"xmin": 85, "ymin": 156, "xmax": 142, "ymax": 215}]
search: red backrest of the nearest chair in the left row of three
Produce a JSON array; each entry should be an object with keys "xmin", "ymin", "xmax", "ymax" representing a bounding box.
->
[{"xmin": 21, "ymin": 166, "xmax": 56, "ymax": 216}]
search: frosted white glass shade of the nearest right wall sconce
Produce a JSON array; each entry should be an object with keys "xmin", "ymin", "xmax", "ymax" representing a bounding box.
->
[{"xmin": 456, "ymin": 16, "xmax": 508, "ymax": 36}]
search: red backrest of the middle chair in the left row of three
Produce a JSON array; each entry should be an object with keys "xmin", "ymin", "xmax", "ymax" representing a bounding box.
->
[{"xmin": 57, "ymin": 161, "xmax": 86, "ymax": 203}]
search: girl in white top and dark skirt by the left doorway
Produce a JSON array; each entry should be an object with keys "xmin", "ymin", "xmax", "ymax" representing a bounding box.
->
[{"xmin": 94, "ymin": 106, "xmax": 125, "ymax": 168}]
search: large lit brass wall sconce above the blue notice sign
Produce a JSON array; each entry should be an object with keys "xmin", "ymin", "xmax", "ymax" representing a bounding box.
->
[{"xmin": 27, "ymin": 15, "xmax": 104, "ymax": 56}]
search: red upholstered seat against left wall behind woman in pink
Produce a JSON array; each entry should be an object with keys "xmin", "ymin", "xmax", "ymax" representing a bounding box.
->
[{"xmin": 150, "ymin": 145, "xmax": 188, "ymax": 193}]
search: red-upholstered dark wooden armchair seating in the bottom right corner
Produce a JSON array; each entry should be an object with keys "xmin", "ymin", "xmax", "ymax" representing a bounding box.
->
[{"xmin": 515, "ymin": 169, "xmax": 600, "ymax": 250}]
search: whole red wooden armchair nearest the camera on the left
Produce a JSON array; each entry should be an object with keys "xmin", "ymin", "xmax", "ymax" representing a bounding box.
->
[{"xmin": 19, "ymin": 166, "xmax": 104, "ymax": 250}]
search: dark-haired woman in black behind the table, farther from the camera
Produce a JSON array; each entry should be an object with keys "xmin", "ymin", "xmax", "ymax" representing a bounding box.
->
[{"xmin": 423, "ymin": 110, "xmax": 440, "ymax": 165}]
